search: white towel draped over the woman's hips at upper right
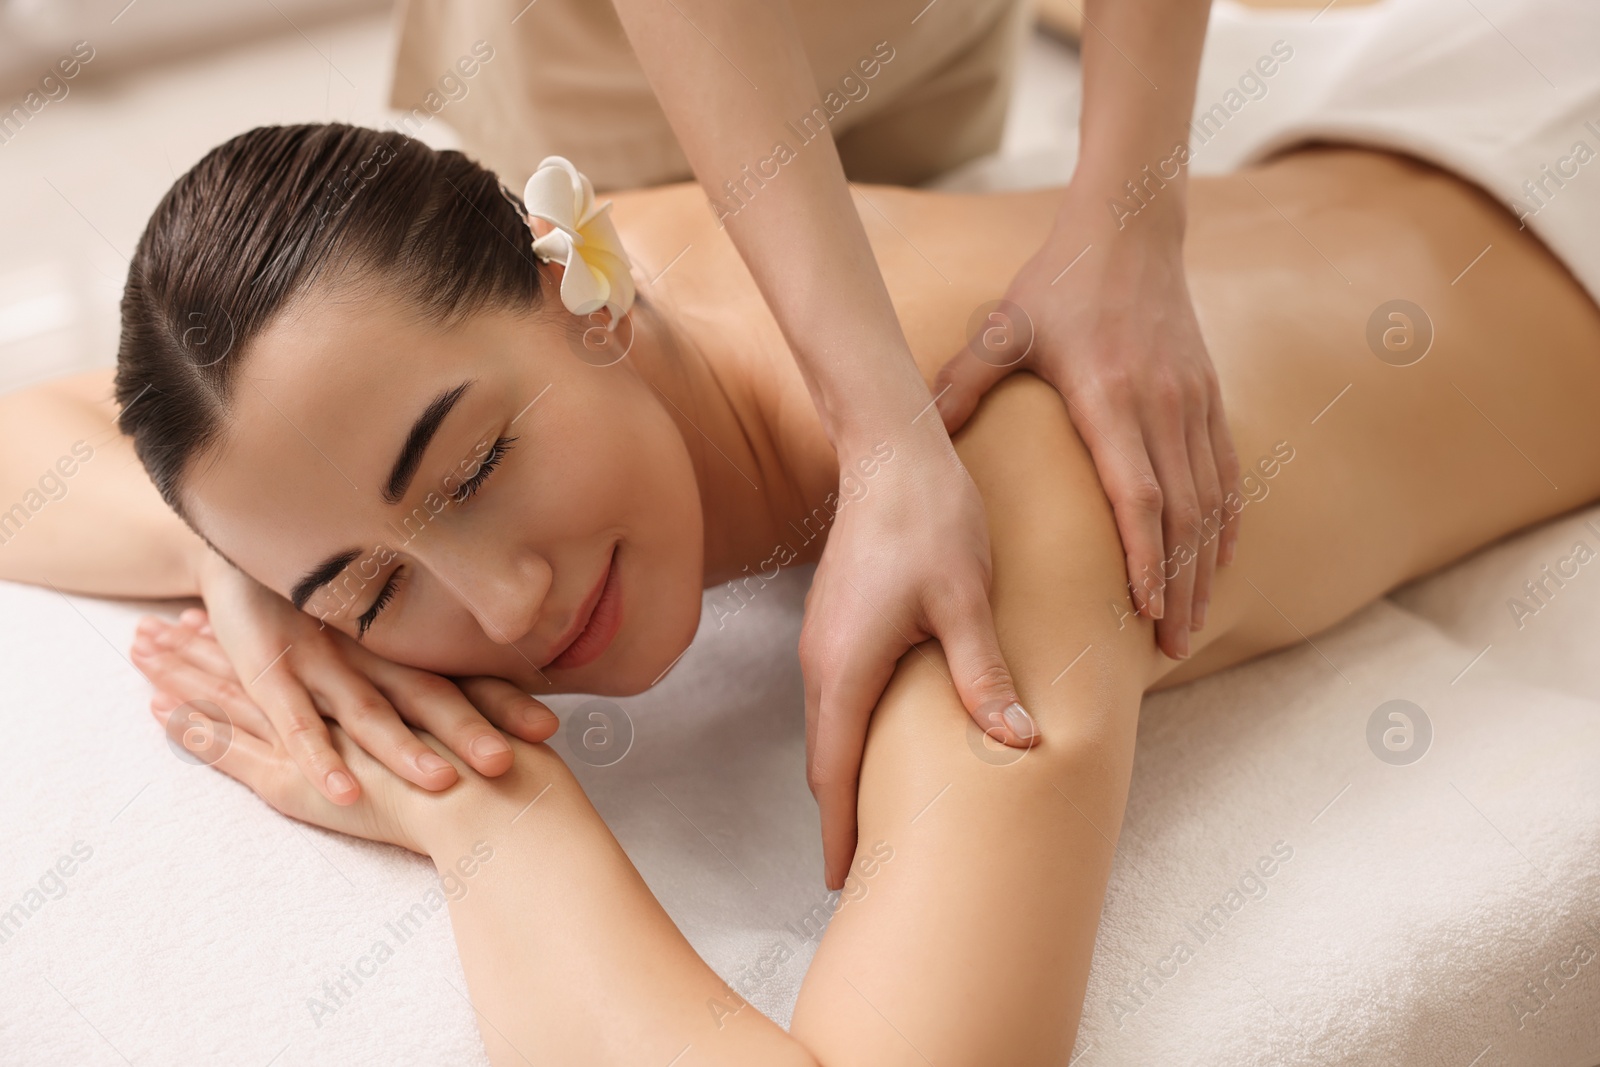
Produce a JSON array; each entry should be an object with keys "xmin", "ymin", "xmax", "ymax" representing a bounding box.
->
[{"xmin": 931, "ymin": 0, "xmax": 1600, "ymax": 302}]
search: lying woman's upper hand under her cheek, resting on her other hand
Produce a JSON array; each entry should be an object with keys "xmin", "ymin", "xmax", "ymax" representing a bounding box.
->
[{"xmin": 133, "ymin": 553, "xmax": 555, "ymax": 805}]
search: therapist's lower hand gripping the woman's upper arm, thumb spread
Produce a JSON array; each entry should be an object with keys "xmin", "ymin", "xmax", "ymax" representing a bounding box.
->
[{"xmin": 800, "ymin": 422, "xmax": 1038, "ymax": 889}]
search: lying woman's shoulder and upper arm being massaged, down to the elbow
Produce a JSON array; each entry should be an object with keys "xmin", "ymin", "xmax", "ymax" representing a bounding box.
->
[{"xmin": 792, "ymin": 374, "xmax": 1155, "ymax": 1065}]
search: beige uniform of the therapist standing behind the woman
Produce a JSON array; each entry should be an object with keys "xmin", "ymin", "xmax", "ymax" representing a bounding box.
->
[{"xmin": 390, "ymin": 0, "xmax": 1029, "ymax": 189}]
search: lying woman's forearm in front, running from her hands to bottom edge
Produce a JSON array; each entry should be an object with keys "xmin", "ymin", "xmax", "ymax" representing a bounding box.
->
[{"xmin": 419, "ymin": 742, "xmax": 816, "ymax": 1067}]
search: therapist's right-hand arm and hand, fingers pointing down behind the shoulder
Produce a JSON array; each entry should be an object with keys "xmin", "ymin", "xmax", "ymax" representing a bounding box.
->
[{"xmin": 938, "ymin": 0, "xmax": 1242, "ymax": 659}]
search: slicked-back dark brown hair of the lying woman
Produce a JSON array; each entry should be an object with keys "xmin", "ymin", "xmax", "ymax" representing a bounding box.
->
[{"xmin": 117, "ymin": 123, "xmax": 539, "ymax": 515}]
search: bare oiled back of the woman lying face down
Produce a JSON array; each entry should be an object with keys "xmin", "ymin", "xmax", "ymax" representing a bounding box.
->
[{"xmin": 616, "ymin": 147, "xmax": 1600, "ymax": 685}]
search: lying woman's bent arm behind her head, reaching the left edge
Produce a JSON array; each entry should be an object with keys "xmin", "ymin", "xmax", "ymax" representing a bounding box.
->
[{"xmin": 0, "ymin": 370, "xmax": 208, "ymax": 597}]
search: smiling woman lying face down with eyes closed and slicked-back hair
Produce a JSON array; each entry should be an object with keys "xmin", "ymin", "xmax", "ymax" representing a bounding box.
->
[{"xmin": 93, "ymin": 112, "xmax": 1600, "ymax": 1067}]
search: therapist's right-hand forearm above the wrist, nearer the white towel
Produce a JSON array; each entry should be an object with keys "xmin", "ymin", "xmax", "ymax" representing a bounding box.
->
[{"xmin": 1069, "ymin": 0, "xmax": 1211, "ymax": 231}]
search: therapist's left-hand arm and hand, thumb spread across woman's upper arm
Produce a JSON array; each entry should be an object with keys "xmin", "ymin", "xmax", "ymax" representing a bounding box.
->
[{"xmin": 601, "ymin": 0, "xmax": 1034, "ymax": 888}]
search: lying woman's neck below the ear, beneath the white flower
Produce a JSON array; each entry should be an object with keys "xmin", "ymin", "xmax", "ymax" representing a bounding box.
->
[{"xmin": 627, "ymin": 301, "xmax": 838, "ymax": 587}]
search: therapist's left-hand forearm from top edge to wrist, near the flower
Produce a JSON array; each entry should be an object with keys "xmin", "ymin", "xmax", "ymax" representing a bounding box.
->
[{"xmin": 616, "ymin": 0, "xmax": 938, "ymax": 445}]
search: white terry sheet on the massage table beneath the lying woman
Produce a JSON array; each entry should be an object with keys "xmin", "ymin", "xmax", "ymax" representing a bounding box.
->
[{"xmin": 0, "ymin": 495, "xmax": 1600, "ymax": 1067}]
